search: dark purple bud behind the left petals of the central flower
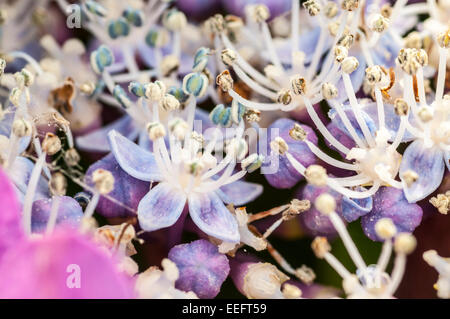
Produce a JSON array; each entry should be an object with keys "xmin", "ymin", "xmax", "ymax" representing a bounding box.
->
[{"xmin": 85, "ymin": 154, "xmax": 150, "ymax": 217}]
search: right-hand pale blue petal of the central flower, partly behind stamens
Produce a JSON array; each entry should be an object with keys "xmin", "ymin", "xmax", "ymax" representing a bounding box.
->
[{"xmin": 218, "ymin": 181, "xmax": 263, "ymax": 206}]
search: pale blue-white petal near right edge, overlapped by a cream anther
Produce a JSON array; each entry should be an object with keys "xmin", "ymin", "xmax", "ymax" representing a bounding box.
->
[{"xmin": 400, "ymin": 140, "xmax": 445, "ymax": 203}]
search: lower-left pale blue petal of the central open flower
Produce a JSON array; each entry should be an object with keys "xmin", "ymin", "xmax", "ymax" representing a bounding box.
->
[{"xmin": 138, "ymin": 183, "xmax": 186, "ymax": 231}]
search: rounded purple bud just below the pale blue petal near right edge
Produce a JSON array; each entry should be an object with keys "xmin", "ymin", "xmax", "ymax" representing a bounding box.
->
[{"xmin": 361, "ymin": 187, "xmax": 423, "ymax": 241}]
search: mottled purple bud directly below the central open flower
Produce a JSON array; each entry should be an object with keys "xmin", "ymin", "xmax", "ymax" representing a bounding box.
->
[{"xmin": 168, "ymin": 239, "xmax": 230, "ymax": 299}]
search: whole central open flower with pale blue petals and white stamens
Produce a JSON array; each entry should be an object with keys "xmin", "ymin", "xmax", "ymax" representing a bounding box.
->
[{"xmin": 109, "ymin": 125, "xmax": 261, "ymax": 242}]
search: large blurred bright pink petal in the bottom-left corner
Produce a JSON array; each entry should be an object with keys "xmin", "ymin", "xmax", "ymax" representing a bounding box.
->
[{"xmin": 0, "ymin": 229, "xmax": 134, "ymax": 299}]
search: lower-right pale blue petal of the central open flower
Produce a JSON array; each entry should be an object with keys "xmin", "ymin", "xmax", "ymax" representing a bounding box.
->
[{"xmin": 188, "ymin": 192, "xmax": 240, "ymax": 242}]
